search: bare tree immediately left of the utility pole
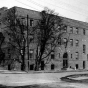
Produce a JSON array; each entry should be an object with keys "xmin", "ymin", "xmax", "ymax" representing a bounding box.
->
[{"xmin": 3, "ymin": 8, "xmax": 27, "ymax": 70}]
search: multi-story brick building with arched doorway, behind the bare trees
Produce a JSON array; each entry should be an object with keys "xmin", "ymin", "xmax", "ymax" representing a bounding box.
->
[{"xmin": 0, "ymin": 7, "xmax": 88, "ymax": 70}]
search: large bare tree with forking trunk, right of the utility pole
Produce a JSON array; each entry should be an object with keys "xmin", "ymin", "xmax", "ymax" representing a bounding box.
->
[{"xmin": 35, "ymin": 9, "xmax": 62, "ymax": 70}]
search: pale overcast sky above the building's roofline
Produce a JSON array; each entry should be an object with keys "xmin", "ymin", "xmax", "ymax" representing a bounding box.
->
[{"xmin": 0, "ymin": 0, "xmax": 88, "ymax": 22}]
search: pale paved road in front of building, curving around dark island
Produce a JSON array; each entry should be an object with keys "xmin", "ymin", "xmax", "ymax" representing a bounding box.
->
[{"xmin": 0, "ymin": 70, "xmax": 88, "ymax": 88}]
